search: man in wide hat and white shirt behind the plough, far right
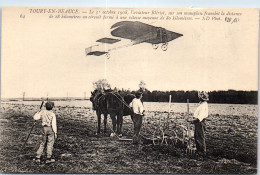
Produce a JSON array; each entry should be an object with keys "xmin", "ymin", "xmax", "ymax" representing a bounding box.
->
[{"xmin": 193, "ymin": 91, "xmax": 209, "ymax": 155}]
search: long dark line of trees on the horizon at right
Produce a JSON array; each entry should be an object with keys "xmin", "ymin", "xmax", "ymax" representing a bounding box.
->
[{"xmin": 119, "ymin": 89, "xmax": 258, "ymax": 104}]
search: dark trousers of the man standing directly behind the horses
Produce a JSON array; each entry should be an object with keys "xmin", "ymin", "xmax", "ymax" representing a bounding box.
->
[{"xmin": 131, "ymin": 114, "xmax": 143, "ymax": 144}]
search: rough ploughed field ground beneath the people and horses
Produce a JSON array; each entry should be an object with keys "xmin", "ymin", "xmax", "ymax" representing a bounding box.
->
[{"xmin": 0, "ymin": 104, "xmax": 257, "ymax": 174}]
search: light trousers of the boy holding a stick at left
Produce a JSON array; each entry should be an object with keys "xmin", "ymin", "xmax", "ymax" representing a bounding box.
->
[{"xmin": 36, "ymin": 126, "xmax": 55, "ymax": 158}]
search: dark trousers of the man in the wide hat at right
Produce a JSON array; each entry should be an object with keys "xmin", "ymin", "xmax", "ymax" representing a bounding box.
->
[{"xmin": 194, "ymin": 119, "xmax": 206, "ymax": 153}]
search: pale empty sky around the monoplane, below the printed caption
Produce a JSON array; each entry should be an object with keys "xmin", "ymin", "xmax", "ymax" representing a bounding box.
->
[{"xmin": 1, "ymin": 9, "xmax": 258, "ymax": 98}]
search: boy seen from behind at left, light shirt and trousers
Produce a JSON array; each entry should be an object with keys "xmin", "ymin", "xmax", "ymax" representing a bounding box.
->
[{"xmin": 33, "ymin": 101, "xmax": 57, "ymax": 163}]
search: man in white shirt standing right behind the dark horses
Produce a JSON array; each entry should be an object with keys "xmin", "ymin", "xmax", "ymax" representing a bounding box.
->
[{"xmin": 129, "ymin": 92, "xmax": 144, "ymax": 144}]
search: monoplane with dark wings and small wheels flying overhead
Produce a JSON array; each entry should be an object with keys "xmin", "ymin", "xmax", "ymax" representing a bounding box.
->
[{"xmin": 85, "ymin": 21, "xmax": 183, "ymax": 59}]
